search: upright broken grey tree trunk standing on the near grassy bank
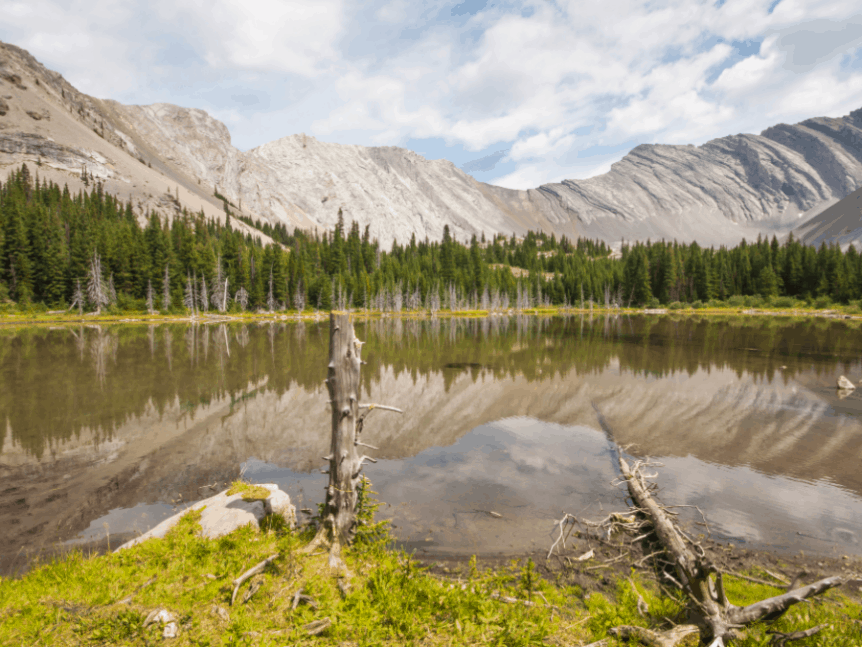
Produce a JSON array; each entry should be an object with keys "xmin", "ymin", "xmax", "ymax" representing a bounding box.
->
[{"xmin": 305, "ymin": 311, "xmax": 401, "ymax": 574}]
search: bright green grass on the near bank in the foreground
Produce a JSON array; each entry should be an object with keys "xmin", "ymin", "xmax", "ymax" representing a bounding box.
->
[{"xmin": 0, "ymin": 491, "xmax": 862, "ymax": 647}]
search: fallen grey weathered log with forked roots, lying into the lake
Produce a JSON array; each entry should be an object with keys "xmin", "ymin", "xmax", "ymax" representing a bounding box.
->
[{"xmin": 596, "ymin": 402, "xmax": 845, "ymax": 647}]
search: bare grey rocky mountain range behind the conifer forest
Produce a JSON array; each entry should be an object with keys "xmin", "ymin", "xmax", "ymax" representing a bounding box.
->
[{"xmin": 0, "ymin": 43, "xmax": 862, "ymax": 247}]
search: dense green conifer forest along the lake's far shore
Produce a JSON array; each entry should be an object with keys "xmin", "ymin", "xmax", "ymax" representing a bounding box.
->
[{"xmin": 0, "ymin": 165, "xmax": 862, "ymax": 312}]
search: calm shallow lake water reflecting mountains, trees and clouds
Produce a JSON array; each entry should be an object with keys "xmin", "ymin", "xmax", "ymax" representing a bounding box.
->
[{"xmin": 0, "ymin": 317, "xmax": 862, "ymax": 572}]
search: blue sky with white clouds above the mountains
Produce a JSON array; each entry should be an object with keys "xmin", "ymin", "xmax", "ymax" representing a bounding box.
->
[{"xmin": 5, "ymin": 0, "xmax": 862, "ymax": 188}]
